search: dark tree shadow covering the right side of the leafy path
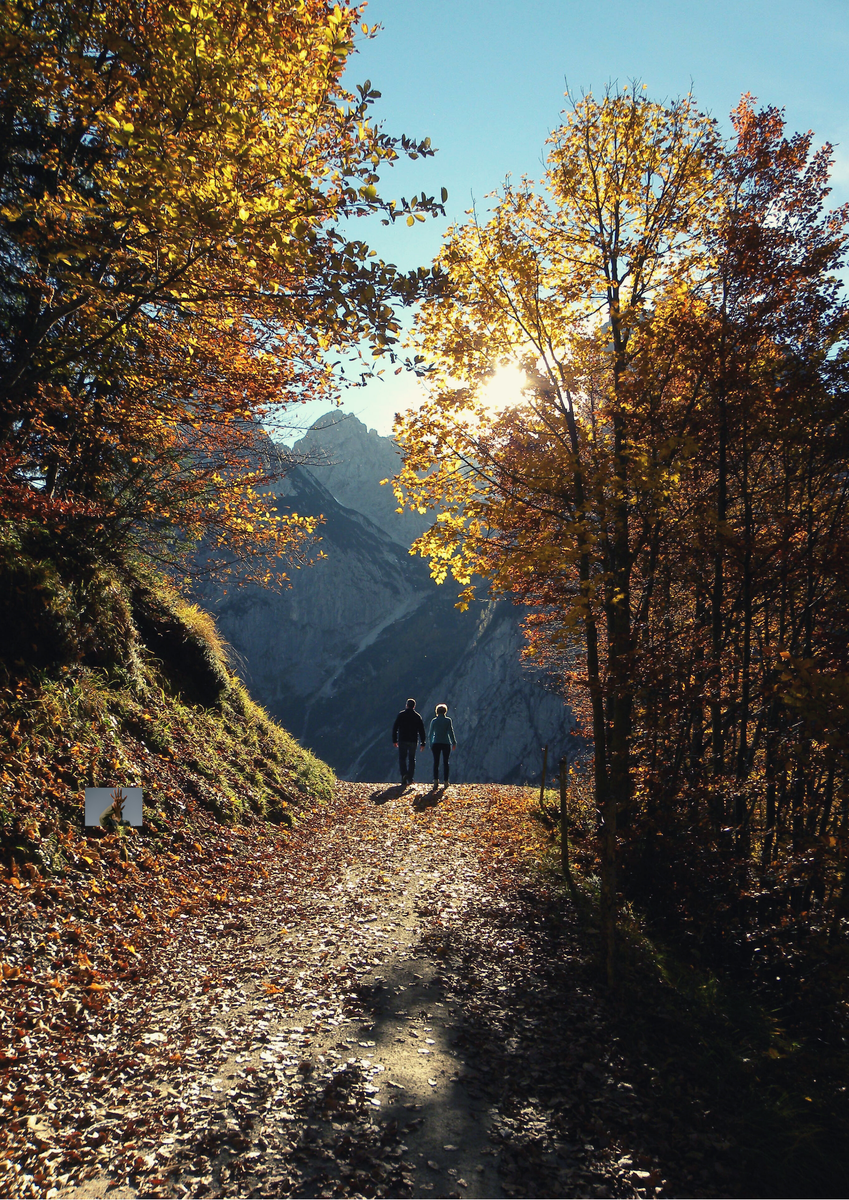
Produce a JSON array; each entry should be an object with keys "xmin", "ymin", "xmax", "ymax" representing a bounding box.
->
[{"xmin": 345, "ymin": 880, "xmax": 724, "ymax": 1196}]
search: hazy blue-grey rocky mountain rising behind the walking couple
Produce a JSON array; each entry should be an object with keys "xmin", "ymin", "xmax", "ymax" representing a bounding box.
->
[{"xmin": 203, "ymin": 414, "xmax": 574, "ymax": 782}]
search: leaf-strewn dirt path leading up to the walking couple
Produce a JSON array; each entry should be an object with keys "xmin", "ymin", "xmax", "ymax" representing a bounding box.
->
[{"xmin": 53, "ymin": 784, "xmax": 735, "ymax": 1198}]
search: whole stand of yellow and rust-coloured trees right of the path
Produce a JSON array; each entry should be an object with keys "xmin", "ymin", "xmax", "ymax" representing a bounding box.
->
[{"xmin": 398, "ymin": 89, "xmax": 849, "ymax": 974}]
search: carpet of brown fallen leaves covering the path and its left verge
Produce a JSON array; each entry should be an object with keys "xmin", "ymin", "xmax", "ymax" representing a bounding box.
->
[{"xmin": 0, "ymin": 784, "xmax": 748, "ymax": 1196}]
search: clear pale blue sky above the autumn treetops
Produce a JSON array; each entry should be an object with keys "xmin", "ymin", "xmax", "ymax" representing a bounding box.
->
[{"xmin": 280, "ymin": 0, "xmax": 849, "ymax": 433}]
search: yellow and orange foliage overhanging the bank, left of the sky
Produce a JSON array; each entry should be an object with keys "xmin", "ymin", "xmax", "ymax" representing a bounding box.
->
[{"xmin": 0, "ymin": 0, "xmax": 448, "ymax": 580}]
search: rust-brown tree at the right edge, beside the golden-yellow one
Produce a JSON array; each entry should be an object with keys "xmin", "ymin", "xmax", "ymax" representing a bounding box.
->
[{"xmin": 644, "ymin": 97, "xmax": 849, "ymax": 907}]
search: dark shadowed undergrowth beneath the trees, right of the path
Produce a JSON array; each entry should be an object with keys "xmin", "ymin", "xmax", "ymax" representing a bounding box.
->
[{"xmin": 539, "ymin": 772, "xmax": 849, "ymax": 1196}]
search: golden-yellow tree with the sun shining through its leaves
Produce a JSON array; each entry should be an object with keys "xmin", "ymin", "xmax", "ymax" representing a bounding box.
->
[{"xmin": 397, "ymin": 86, "xmax": 719, "ymax": 977}]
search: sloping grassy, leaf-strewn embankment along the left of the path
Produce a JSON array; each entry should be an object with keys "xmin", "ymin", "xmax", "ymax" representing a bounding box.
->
[{"xmin": 0, "ymin": 530, "xmax": 335, "ymax": 1032}]
